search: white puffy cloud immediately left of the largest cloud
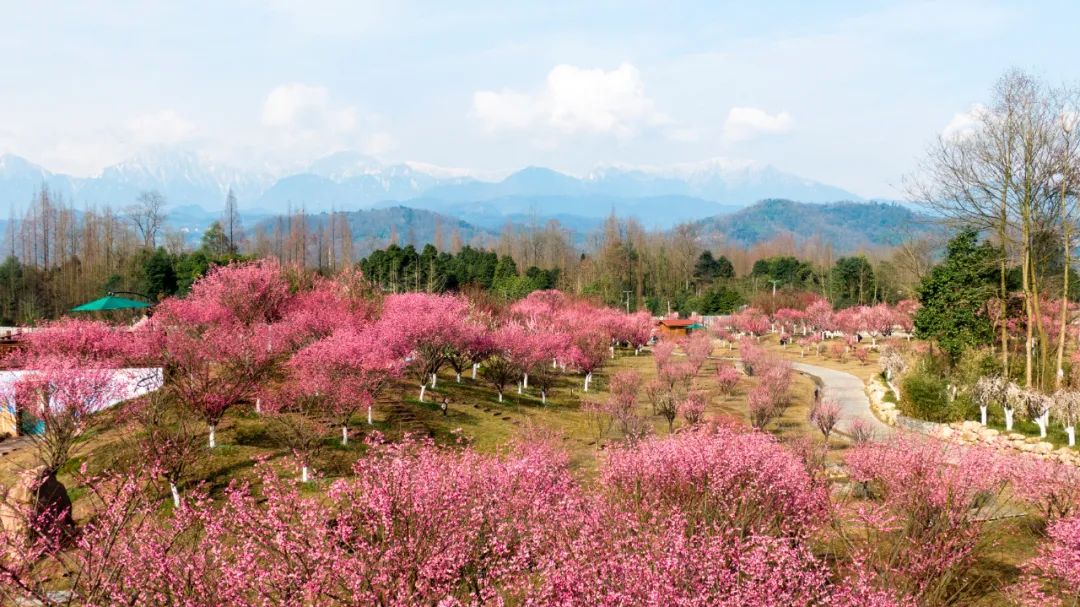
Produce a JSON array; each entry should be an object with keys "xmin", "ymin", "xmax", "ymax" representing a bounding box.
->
[{"xmin": 262, "ymin": 82, "xmax": 356, "ymax": 131}]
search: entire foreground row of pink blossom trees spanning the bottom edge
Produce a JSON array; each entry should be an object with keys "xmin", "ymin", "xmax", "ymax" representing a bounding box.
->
[{"xmin": 0, "ymin": 424, "xmax": 1080, "ymax": 607}]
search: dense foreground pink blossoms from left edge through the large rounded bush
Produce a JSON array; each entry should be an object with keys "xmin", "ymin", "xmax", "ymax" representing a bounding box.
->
[{"xmin": 0, "ymin": 428, "xmax": 915, "ymax": 607}]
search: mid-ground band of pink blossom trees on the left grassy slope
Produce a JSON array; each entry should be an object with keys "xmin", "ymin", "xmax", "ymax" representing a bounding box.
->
[{"xmin": 5, "ymin": 260, "xmax": 652, "ymax": 492}]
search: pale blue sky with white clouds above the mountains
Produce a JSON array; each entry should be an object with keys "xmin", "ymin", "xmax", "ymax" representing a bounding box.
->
[{"xmin": 0, "ymin": 0, "xmax": 1080, "ymax": 198}]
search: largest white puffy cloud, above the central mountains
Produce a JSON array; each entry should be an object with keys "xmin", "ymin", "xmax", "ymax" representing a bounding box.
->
[{"xmin": 473, "ymin": 64, "xmax": 670, "ymax": 138}]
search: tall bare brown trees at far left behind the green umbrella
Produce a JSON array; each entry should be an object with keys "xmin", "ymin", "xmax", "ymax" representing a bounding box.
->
[{"xmin": 0, "ymin": 186, "xmax": 244, "ymax": 325}]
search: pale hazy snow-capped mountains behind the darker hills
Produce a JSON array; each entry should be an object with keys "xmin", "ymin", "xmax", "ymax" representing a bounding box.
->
[{"xmin": 0, "ymin": 148, "xmax": 860, "ymax": 217}]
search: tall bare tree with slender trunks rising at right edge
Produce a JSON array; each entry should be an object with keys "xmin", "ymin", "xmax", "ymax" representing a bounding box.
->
[{"xmin": 908, "ymin": 70, "xmax": 1076, "ymax": 387}]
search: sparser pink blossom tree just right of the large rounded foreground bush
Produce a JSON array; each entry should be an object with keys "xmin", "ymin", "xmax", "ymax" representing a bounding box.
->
[{"xmin": 837, "ymin": 433, "xmax": 1015, "ymax": 604}]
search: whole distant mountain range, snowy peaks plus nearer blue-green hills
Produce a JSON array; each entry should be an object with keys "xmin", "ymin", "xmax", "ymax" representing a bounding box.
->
[{"xmin": 0, "ymin": 149, "xmax": 937, "ymax": 252}]
